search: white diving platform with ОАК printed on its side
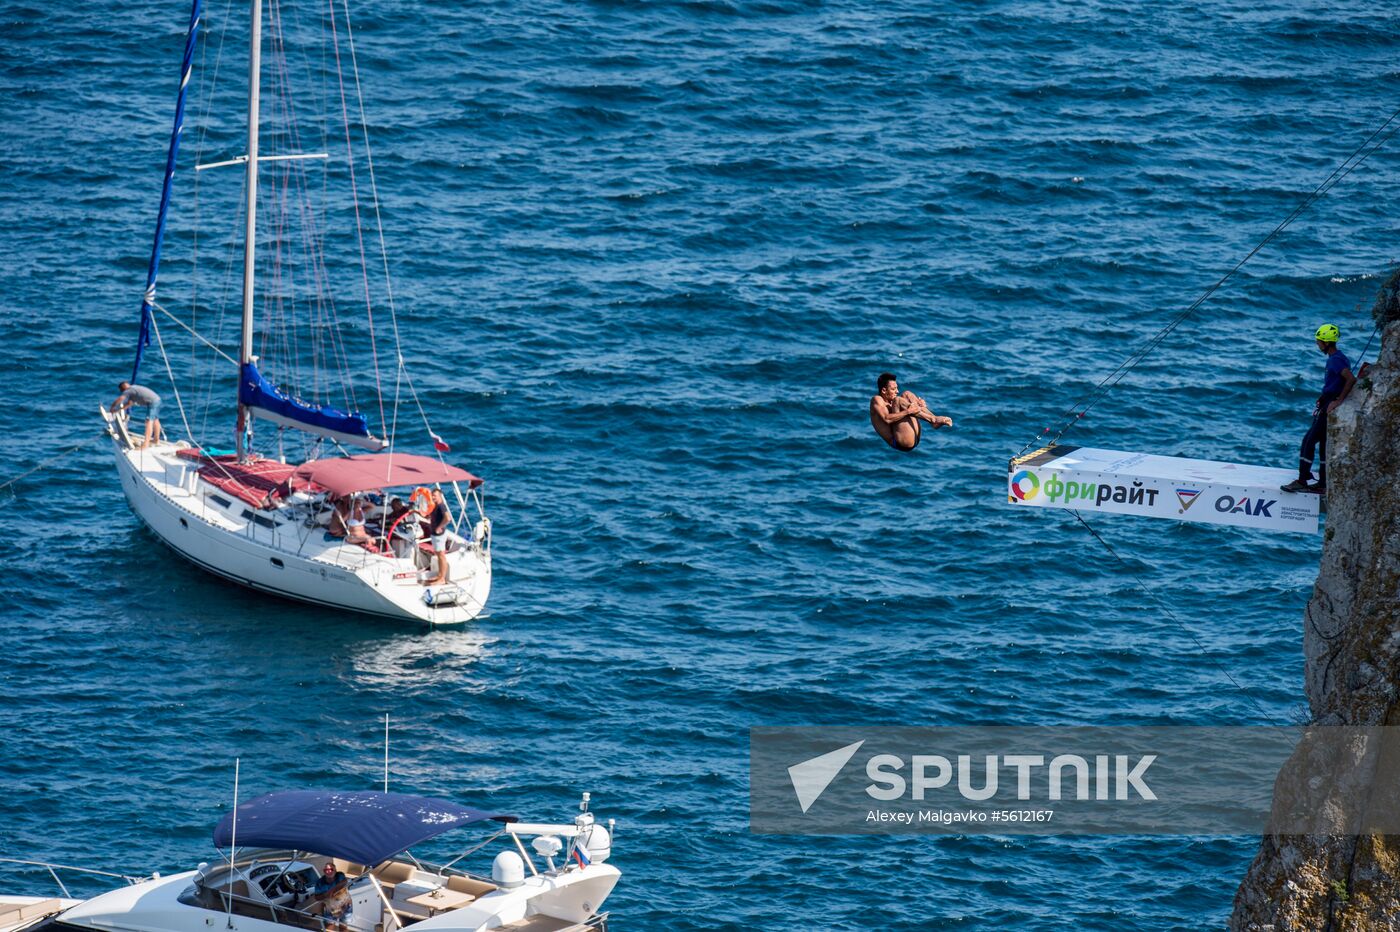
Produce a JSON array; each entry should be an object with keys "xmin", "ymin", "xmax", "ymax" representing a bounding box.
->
[{"xmin": 1007, "ymin": 445, "xmax": 1322, "ymax": 533}]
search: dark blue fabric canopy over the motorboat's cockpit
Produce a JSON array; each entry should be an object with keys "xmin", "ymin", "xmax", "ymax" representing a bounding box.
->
[{"xmin": 214, "ymin": 789, "xmax": 517, "ymax": 866}]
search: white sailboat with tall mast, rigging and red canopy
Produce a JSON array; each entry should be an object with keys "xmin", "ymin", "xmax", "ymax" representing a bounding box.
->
[{"xmin": 101, "ymin": 0, "xmax": 491, "ymax": 624}]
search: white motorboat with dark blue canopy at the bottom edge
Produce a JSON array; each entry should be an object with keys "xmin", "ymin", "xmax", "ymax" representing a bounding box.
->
[{"xmin": 8, "ymin": 791, "xmax": 620, "ymax": 932}]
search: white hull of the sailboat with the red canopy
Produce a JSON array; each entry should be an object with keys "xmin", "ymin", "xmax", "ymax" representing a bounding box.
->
[{"xmin": 107, "ymin": 432, "xmax": 491, "ymax": 626}]
